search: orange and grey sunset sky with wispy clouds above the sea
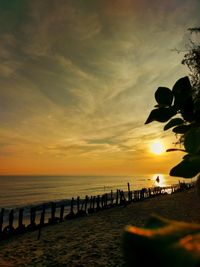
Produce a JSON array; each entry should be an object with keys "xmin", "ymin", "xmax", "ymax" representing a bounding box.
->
[{"xmin": 0, "ymin": 0, "xmax": 200, "ymax": 175}]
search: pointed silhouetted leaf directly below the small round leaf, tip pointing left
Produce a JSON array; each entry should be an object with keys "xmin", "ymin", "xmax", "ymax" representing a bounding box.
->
[{"xmin": 145, "ymin": 107, "xmax": 176, "ymax": 124}]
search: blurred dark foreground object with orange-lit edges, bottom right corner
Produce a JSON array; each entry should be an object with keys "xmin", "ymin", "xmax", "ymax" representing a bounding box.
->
[{"xmin": 123, "ymin": 215, "xmax": 200, "ymax": 267}]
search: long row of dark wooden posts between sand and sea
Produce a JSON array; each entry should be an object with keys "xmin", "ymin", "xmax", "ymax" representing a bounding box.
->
[{"xmin": 0, "ymin": 182, "xmax": 194, "ymax": 240}]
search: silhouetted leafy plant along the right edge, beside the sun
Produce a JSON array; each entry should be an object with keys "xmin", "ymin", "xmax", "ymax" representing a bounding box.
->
[{"xmin": 145, "ymin": 28, "xmax": 200, "ymax": 178}]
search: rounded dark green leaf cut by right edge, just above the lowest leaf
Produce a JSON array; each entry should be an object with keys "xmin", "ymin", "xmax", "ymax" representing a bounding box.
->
[{"xmin": 184, "ymin": 127, "xmax": 200, "ymax": 154}]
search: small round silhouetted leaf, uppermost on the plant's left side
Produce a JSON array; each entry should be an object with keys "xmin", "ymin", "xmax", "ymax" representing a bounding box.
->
[{"xmin": 155, "ymin": 87, "xmax": 174, "ymax": 106}]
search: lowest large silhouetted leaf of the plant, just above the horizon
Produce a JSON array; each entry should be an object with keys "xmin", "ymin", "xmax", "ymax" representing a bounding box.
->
[{"xmin": 170, "ymin": 155, "xmax": 200, "ymax": 178}]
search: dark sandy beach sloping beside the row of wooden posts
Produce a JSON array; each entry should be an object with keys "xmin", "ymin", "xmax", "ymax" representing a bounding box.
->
[{"xmin": 0, "ymin": 189, "xmax": 200, "ymax": 267}]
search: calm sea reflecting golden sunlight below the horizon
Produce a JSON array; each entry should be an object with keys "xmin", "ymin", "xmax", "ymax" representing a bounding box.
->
[{"xmin": 0, "ymin": 174, "xmax": 189, "ymax": 209}]
